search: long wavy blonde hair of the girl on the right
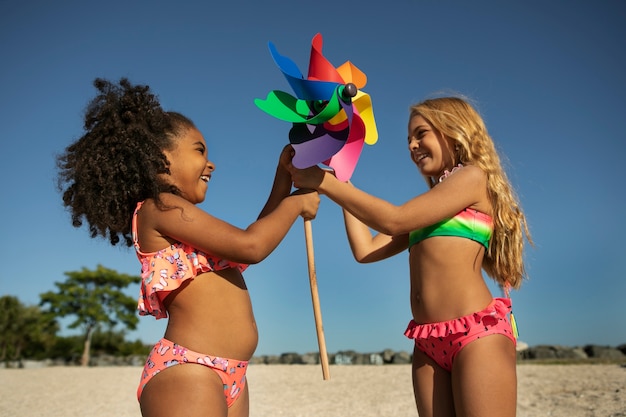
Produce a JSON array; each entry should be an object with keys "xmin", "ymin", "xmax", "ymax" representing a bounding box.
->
[{"xmin": 410, "ymin": 97, "xmax": 532, "ymax": 289}]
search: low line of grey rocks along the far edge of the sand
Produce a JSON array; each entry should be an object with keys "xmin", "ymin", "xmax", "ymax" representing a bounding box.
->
[{"xmin": 4, "ymin": 342, "xmax": 626, "ymax": 369}]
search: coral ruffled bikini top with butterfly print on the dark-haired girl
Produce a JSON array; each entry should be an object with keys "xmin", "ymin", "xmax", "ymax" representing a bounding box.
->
[{"xmin": 132, "ymin": 201, "xmax": 248, "ymax": 319}]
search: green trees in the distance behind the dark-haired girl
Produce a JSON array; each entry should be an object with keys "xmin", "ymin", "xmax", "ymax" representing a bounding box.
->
[{"xmin": 0, "ymin": 266, "xmax": 151, "ymax": 363}]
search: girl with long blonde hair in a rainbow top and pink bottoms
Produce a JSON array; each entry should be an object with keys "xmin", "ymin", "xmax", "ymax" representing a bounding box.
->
[{"xmin": 289, "ymin": 97, "xmax": 531, "ymax": 417}]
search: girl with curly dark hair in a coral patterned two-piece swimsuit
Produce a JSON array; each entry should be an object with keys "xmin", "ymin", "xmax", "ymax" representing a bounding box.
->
[{"xmin": 58, "ymin": 79, "xmax": 319, "ymax": 417}]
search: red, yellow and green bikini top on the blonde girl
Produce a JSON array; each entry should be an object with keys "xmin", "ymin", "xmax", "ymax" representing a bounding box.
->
[{"xmin": 409, "ymin": 207, "xmax": 493, "ymax": 249}]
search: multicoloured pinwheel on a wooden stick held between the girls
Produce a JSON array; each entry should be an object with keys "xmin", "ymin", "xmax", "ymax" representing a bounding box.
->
[{"xmin": 254, "ymin": 33, "xmax": 378, "ymax": 380}]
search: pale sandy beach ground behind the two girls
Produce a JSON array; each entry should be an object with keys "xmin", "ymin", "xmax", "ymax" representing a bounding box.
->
[{"xmin": 0, "ymin": 363, "xmax": 626, "ymax": 417}]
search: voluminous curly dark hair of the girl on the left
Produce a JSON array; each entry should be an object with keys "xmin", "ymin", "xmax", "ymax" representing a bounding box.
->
[{"xmin": 57, "ymin": 78, "xmax": 195, "ymax": 246}]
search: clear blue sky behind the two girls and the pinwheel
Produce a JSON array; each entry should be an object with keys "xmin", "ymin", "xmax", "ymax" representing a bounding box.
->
[{"xmin": 0, "ymin": 0, "xmax": 626, "ymax": 354}]
